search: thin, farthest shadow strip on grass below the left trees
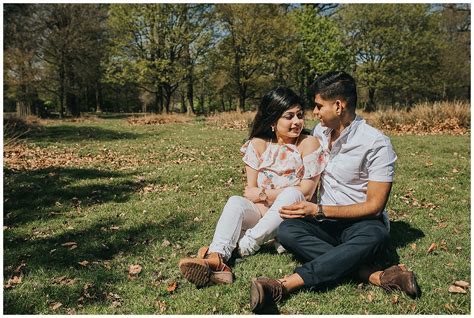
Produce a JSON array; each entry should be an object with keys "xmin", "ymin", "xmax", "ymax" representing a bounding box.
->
[{"xmin": 28, "ymin": 125, "xmax": 138, "ymax": 143}]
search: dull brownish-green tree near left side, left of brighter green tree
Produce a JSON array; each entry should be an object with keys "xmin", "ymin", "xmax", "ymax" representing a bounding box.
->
[{"xmin": 38, "ymin": 4, "xmax": 105, "ymax": 117}]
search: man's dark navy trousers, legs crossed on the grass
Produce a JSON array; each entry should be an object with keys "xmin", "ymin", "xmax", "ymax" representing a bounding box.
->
[{"xmin": 277, "ymin": 218, "xmax": 389, "ymax": 287}]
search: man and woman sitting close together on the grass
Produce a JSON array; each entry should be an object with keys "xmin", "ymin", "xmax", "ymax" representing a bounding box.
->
[{"xmin": 179, "ymin": 72, "xmax": 420, "ymax": 313}]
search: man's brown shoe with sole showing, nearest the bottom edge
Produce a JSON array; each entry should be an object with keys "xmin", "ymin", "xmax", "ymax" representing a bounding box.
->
[{"xmin": 250, "ymin": 277, "xmax": 284, "ymax": 313}]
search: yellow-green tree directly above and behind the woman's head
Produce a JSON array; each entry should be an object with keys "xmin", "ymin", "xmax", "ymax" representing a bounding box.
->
[{"xmin": 216, "ymin": 4, "xmax": 296, "ymax": 111}]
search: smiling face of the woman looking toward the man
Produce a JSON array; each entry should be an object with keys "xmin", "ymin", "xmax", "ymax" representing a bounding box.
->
[{"xmin": 275, "ymin": 105, "xmax": 304, "ymax": 141}]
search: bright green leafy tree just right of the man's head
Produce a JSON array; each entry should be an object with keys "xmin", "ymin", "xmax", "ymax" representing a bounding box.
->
[{"xmin": 339, "ymin": 4, "xmax": 441, "ymax": 111}]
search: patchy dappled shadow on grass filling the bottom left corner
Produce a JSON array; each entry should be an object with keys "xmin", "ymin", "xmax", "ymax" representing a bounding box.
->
[{"xmin": 4, "ymin": 211, "xmax": 195, "ymax": 314}]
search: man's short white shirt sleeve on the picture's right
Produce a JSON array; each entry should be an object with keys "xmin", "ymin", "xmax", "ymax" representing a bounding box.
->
[{"xmin": 367, "ymin": 136, "xmax": 397, "ymax": 182}]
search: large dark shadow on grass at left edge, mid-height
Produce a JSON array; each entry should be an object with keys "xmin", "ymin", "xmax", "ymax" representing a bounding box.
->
[{"xmin": 4, "ymin": 167, "xmax": 148, "ymax": 226}]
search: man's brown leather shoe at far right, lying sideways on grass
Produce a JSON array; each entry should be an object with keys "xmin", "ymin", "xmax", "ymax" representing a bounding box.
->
[{"xmin": 380, "ymin": 265, "xmax": 420, "ymax": 298}]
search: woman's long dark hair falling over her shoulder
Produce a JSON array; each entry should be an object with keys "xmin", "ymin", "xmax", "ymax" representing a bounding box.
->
[{"xmin": 249, "ymin": 86, "xmax": 304, "ymax": 139}]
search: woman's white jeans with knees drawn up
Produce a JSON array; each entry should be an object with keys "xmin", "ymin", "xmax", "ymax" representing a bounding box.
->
[{"xmin": 209, "ymin": 187, "xmax": 305, "ymax": 260}]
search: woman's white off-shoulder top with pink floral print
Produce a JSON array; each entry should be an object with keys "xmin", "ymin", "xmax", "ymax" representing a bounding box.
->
[{"xmin": 240, "ymin": 140, "xmax": 327, "ymax": 189}]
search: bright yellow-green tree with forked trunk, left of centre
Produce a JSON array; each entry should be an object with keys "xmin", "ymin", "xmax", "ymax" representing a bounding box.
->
[{"xmin": 107, "ymin": 4, "xmax": 189, "ymax": 112}]
